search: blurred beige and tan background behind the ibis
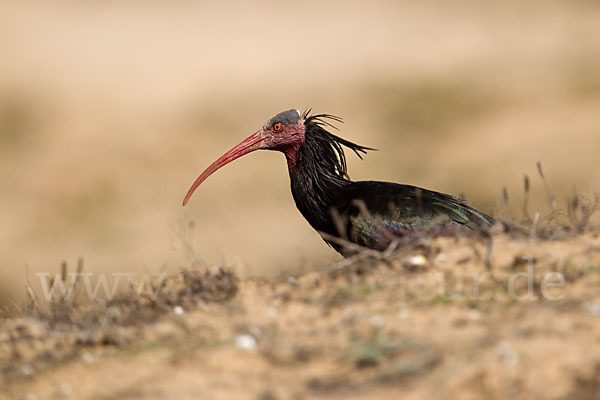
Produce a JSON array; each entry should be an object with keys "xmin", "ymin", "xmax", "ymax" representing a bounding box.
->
[{"xmin": 0, "ymin": 0, "xmax": 600, "ymax": 302}]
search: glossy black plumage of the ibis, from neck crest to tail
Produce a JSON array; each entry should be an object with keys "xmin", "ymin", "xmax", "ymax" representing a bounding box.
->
[{"xmin": 290, "ymin": 113, "xmax": 494, "ymax": 254}]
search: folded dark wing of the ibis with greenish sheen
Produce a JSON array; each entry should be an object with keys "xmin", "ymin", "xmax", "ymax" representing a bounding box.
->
[{"xmin": 344, "ymin": 181, "xmax": 494, "ymax": 249}]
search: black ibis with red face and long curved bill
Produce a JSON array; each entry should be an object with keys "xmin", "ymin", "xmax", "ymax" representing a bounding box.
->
[{"xmin": 183, "ymin": 109, "xmax": 494, "ymax": 257}]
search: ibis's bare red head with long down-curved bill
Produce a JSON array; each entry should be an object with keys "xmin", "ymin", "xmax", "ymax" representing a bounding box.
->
[{"xmin": 183, "ymin": 109, "xmax": 306, "ymax": 205}]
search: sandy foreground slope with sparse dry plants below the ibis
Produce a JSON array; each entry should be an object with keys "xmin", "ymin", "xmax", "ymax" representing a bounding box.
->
[{"xmin": 0, "ymin": 233, "xmax": 600, "ymax": 400}]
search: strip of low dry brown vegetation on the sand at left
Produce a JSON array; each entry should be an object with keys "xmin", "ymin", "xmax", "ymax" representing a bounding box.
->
[{"xmin": 0, "ymin": 260, "xmax": 238, "ymax": 384}]
